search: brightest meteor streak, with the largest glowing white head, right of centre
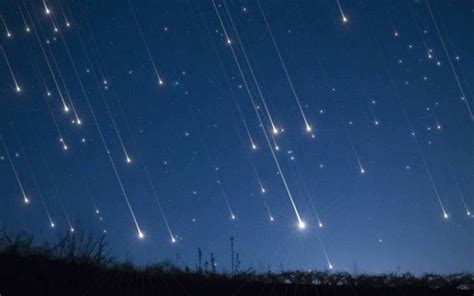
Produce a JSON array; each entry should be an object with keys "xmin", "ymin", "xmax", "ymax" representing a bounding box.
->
[{"xmin": 209, "ymin": 1, "xmax": 306, "ymax": 229}]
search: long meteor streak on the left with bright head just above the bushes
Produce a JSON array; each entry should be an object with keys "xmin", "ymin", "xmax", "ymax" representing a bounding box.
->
[{"xmin": 64, "ymin": 18, "xmax": 145, "ymax": 239}]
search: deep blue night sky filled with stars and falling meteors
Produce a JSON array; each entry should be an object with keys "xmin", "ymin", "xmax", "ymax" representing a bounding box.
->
[{"xmin": 0, "ymin": 0, "xmax": 474, "ymax": 273}]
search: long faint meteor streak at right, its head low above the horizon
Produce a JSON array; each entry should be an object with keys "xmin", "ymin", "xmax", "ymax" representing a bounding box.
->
[{"xmin": 367, "ymin": 19, "xmax": 449, "ymax": 219}]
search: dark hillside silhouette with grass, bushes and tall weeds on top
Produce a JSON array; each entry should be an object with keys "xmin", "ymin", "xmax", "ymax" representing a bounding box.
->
[{"xmin": 0, "ymin": 229, "xmax": 474, "ymax": 296}]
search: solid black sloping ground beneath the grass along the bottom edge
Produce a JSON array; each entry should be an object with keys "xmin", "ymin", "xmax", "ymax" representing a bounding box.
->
[{"xmin": 0, "ymin": 254, "xmax": 473, "ymax": 296}]
